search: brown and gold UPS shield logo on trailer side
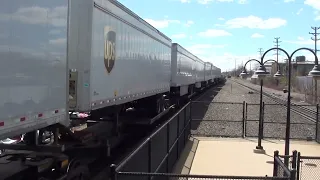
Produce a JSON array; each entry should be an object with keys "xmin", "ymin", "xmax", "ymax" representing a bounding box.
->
[{"xmin": 104, "ymin": 26, "xmax": 116, "ymax": 73}]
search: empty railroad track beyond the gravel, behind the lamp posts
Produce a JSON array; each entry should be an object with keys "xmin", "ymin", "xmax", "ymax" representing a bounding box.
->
[{"xmin": 232, "ymin": 80, "xmax": 317, "ymax": 123}]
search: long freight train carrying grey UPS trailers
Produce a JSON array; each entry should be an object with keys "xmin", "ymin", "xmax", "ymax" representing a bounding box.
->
[{"xmin": 0, "ymin": 0, "xmax": 222, "ymax": 178}]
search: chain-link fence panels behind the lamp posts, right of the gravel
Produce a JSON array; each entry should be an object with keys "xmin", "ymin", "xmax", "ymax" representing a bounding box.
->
[{"xmin": 244, "ymin": 103, "xmax": 320, "ymax": 142}]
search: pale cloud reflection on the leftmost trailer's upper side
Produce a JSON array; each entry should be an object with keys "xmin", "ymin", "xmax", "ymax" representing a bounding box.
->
[{"xmin": 0, "ymin": 6, "xmax": 67, "ymax": 27}]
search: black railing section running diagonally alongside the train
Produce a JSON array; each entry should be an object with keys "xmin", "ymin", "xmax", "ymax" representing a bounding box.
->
[{"xmin": 115, "ymin": 103, "xmax": 191, "ymax": 180}]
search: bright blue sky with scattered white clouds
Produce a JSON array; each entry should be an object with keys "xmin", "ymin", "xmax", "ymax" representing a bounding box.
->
[{"xmin": 119, "ymin": 0, "xmax": 320, "ymax": 71}]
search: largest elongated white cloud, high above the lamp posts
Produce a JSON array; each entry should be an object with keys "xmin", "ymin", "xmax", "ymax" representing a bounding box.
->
[{"xmin": 218, "ymin": 15, "xmax": 287, "ymax": 29}]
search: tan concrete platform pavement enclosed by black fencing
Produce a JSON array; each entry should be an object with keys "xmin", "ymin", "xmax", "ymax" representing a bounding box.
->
[{"xmin": 173, "ymin": 137, "xmax": 320, "ymax": 177}]
